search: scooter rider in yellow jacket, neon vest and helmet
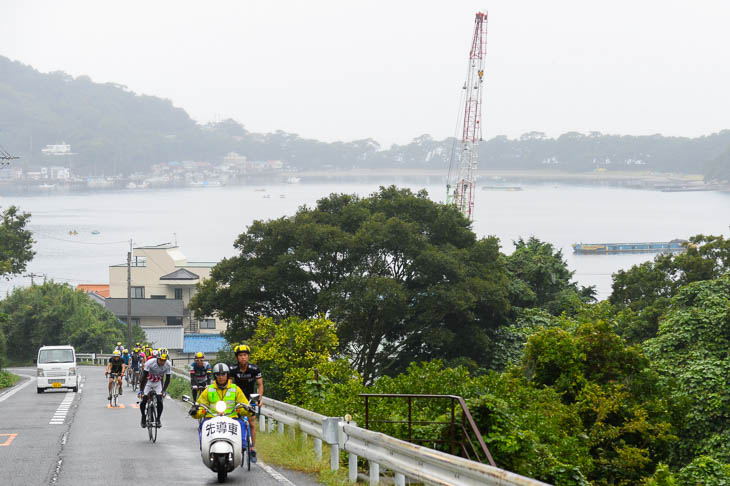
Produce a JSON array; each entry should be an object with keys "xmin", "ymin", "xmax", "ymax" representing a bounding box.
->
[{"xmin": 188, "ymin": 363, "xmax": 255, "ymax": 456}]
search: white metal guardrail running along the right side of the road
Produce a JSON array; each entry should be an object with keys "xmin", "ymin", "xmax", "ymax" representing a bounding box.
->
[{"xmin": 161, "ymin": 370, "xmax": 549, "ymax": 486}]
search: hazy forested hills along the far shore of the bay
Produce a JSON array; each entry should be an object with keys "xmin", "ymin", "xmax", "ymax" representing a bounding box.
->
[{"xmin": 0, "ymin": 56, "xmax": 730, "ymax": 180}]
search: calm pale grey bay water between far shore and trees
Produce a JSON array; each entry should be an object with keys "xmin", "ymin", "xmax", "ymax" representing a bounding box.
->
[{"xmin": 0, "ymin": 183, "xmax": 730, "ymax": 299}]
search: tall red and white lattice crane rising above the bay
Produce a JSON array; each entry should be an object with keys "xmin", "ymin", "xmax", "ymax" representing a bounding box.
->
[{"xmin": 446, "ymin": 12, "xmax": 487, "ymax": 220}]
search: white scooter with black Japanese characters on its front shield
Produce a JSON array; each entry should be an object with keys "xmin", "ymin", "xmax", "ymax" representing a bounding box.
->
[{"xmin": 182, "ymin": 395, "xmax": 258, "ymax": 483}]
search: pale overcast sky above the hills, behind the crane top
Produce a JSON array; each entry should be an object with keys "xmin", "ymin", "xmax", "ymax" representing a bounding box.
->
[{"xmin": 0, "ymin": 0, "xmax": 730, "ymax": 148}]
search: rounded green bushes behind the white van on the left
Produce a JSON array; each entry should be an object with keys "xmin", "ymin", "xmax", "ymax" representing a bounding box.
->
[{"xmin": 0, "ymin": 282, "xmax": 144, "ymax": 363}]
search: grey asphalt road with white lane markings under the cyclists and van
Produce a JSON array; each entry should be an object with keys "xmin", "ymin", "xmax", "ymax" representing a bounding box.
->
[{"xmin": 0, "ymin": 366, "xmax": 318, "ymax": 486}]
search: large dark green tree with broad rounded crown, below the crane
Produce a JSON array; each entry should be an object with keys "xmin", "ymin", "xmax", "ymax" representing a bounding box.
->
[{"xmin": 192, "ymin": 186, "xmax": 509, "ymax": 382}]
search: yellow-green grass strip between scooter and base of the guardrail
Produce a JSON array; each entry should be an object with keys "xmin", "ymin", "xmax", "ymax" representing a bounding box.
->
[{"xmin": 256, "ymin": 432, "xmax": 366, "ymax": 486}]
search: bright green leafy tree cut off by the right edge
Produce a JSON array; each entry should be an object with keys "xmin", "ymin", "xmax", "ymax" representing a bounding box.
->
[{"xmin": 644, "ymin": 276, "xmax": 730, "ymax": 464}]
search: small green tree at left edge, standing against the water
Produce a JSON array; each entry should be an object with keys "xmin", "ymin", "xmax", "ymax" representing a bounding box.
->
[{"xmin": 0, "ymin": 206, "xmax": 35, "ymax": 276}]
